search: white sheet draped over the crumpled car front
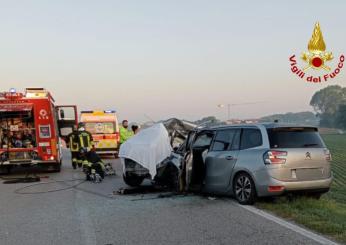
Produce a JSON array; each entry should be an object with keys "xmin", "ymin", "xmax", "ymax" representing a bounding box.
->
[{"xmin": 119, "ymin": 123, "xmax": 172, "ymax": 178}]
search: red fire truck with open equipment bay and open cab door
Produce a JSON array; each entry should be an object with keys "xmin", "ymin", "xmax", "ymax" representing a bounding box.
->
[{"xmin": 0, "ymin": 88, "xmax": 78, "ymax": 172}]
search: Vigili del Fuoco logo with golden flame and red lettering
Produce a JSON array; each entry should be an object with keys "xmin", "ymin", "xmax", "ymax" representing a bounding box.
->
[{"xmin": 289, "ymin": 22, "xmax": 345, "ymax": 83}]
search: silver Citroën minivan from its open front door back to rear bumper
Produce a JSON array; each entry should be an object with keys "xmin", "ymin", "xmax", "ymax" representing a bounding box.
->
[{"xmin": 171, "ymin": 123, "xmax": 332, "ymax": 204}]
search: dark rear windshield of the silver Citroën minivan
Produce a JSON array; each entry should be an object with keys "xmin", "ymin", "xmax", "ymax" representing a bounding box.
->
[{"xmin": 267, "ymin": 128, "xmax": 325, "ymax": 148}]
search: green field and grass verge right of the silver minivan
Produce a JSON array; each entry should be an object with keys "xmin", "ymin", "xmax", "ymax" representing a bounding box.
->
[{"xmin": 257, "ymin": 135, "xmax": 346, "ymax": 243}]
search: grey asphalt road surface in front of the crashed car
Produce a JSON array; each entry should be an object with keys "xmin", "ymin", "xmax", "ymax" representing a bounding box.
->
[{"xmin": 0, "ymin": 150, "xmax": 336, "ymax": 245}]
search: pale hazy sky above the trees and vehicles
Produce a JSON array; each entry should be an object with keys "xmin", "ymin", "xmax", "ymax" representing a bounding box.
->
[{"xmin": 0, "ymin": 0, "xmax": 346, "ymax": 122}]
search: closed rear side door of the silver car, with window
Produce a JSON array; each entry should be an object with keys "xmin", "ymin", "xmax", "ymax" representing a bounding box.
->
[{"xmin": 204, "ymin": 128, "xmax": 241, "ymax": 193}]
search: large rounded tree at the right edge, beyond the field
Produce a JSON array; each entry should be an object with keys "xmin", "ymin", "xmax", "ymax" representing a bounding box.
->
[{"xmin": 310, "ymin": 85, "xmax": 346, "ymax": 129}]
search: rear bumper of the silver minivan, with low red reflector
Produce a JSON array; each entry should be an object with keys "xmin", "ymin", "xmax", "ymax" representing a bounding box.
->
[{"xmin": 256, "ymin": 174, "xmax": 333, "ymax": 196}]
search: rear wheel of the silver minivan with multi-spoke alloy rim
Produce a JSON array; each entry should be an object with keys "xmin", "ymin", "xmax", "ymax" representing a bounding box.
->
[{"xmin": 233, "ymin": 173, "xmax": 256, "ymax": 205}]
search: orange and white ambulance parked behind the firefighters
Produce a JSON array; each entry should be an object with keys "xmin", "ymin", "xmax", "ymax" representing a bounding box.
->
[{"xmin": 80, "ymin": 110, "xmax": 120, "ymax": 155}]
